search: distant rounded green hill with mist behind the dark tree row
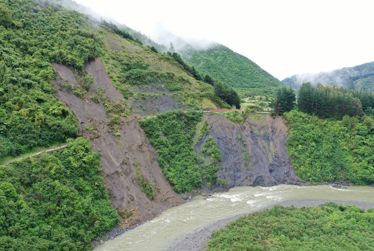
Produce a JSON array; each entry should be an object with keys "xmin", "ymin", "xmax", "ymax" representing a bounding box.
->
[{"xmin": 181, "ymin": 45, "xmax": 281, "ymax": 96}]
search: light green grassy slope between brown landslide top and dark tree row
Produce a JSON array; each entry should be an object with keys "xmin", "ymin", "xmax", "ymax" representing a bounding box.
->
[{"xmin": 100, "ymin": 25, "xmax": 227, "ymax": 109}]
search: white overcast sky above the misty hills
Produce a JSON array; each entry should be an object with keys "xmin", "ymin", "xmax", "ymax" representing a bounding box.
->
[{"xmin": 76, "ymin": 0, "xmax": 374, "ymax": 79}]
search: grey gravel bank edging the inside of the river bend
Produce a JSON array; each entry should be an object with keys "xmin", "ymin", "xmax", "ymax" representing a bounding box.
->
[{"xmin": 168, "ymin": 200, "xmax": 374, "ymax": 251}]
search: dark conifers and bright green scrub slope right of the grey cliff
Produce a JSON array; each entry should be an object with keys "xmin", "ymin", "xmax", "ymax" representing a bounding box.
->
[{"xmin": 274, "ymin": 83, "xmax": 374, "ymax": 184}]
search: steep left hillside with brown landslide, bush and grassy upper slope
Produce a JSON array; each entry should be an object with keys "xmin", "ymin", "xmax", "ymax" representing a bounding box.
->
[{"xmin": 0, "ymin": 0, "xmax": 215, "ymax": 247}]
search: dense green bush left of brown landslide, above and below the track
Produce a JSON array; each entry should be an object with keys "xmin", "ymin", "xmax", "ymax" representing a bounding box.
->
[{"xmin": 0, "ymin": 0, "xmax": 118, "ymax": 250}]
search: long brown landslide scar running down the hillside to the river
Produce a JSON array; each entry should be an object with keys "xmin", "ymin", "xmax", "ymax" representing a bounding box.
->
[{"xmin": 54, "ymin": 59, "xmax": 182, "ymax": 227}]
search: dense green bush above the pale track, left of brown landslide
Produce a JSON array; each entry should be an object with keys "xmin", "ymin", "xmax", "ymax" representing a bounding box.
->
[{"xmin": 0, "ymin": 0, "xmax": 100, "ymax": 158}]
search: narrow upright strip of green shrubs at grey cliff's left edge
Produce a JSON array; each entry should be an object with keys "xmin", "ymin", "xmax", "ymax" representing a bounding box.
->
[{"xmin": 201, "ymin": 136, "xmax": 221, "ymax": 188}]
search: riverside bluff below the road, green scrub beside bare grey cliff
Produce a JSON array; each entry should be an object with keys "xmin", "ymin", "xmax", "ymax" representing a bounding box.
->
[{"xmin": 141, "ymin": 113, "xmax": 299, "ymax": 192}]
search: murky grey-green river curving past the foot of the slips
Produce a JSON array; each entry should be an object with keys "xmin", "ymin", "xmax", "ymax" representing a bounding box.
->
[{"xmin": 95, "ymin": 185, "xmax": 374, "ymax": 251}]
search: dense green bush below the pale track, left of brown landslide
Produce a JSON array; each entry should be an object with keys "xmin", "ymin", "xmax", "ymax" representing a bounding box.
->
[{"xmin": 0, "ymin": 138, "xmax": 118, "ymax": 251}]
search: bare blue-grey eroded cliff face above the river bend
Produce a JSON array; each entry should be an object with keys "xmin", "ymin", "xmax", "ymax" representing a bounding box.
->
[{"xmin": 195, "ymin": 114, "xmax": 299, "ymax": 187}]
